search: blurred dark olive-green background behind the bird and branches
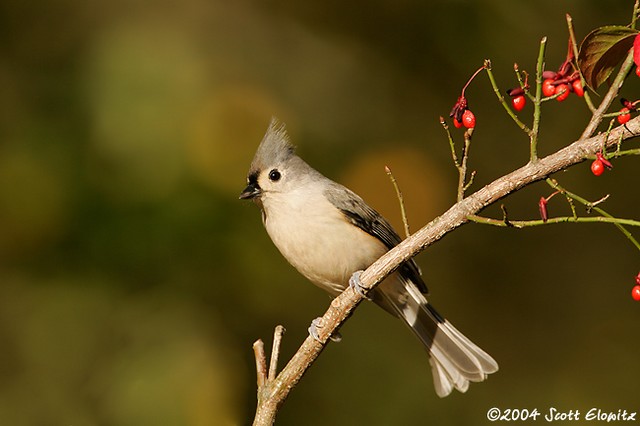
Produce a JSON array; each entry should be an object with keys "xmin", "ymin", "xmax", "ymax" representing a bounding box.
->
[{"xmin": 0, "ymin": 0, "xmax": 640, "ymax": 426}]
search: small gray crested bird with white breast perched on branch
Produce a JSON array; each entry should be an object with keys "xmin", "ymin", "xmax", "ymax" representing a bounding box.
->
[{"xmin": 240, "ymin": 119, "xmax": 498, "ymax": 397}]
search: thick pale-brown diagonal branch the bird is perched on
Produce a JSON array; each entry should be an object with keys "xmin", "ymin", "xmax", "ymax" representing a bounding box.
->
[{"xmin": 254, "ymin": 115, "xmax": 640, "ymax": 425}]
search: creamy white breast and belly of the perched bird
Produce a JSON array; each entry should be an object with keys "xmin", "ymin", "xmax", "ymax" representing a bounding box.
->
[{"xmin": 263, "ymin": 188, "xmax": 387, "ymax": 295}]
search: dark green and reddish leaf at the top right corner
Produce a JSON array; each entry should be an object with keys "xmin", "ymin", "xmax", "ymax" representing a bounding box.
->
[{"xmin": 578, "ymin": 26, "xmax": 638, "ymax": 90}]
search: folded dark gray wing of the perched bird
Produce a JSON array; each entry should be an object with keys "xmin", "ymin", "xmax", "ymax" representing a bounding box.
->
[{"xmin": 325, "ymin": 182, "xmax": 428, "ymax": 294}]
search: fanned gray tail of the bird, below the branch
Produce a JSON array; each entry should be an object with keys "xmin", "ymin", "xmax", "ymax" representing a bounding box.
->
[{"xmin": 374, "ymin": 280, "xmax": 498, "ymax": 397}]
